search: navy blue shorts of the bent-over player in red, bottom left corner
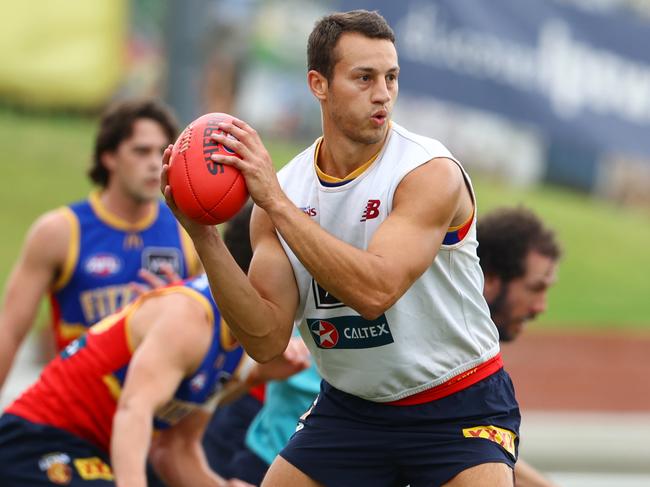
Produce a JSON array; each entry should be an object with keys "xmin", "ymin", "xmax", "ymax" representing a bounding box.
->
[{"xmin": 0, "ymin": 414, "xmax": 115, "ymax": 487}]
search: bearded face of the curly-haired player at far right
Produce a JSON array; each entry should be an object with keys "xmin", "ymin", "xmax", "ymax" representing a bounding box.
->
[{"xmin": 488, "ymin": 251, "xmax": 557, "ymax": 342}]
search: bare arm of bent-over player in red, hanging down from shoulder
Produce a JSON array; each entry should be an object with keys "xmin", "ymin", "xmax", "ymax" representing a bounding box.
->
[{"xmin": 111, "ymin": 293, "xmax": 214, "ymax": 487}]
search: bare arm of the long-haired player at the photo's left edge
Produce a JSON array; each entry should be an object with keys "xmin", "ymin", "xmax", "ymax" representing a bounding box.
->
[{"xmin": 0, "ymin": 210, "xmax": 70, "ymax": 390}]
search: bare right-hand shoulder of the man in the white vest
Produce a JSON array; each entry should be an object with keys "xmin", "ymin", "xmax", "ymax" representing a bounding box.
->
[{"xmin": 393, "ymin": 157, "xmax": 472, "ymax": 230}]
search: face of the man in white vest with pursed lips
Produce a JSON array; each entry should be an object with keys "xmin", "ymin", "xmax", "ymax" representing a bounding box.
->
[{"xmin": 324, "ymin": 33, "xmax": 399, "ymax": 144}]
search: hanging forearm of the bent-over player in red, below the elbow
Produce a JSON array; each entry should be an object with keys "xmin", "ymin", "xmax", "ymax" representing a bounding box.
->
[{"xmin": 111, "ymin": 407, "xmax": 152, "ymax": 487}]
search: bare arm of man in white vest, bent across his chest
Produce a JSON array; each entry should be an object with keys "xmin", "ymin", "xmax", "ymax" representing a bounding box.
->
[{"xmin": 215, "ymin": 121, "xmax": 472, "ymax": 319}]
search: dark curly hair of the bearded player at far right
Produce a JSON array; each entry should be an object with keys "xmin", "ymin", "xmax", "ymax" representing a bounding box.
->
[{"xmin": 476, "ymin": 207, "xmax": 562, "ymax": 282}]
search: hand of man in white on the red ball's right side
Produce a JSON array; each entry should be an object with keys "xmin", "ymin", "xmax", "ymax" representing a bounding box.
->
[{"xmin": 211, "ymin": 119, "xmax": 284, "ymax": 210}]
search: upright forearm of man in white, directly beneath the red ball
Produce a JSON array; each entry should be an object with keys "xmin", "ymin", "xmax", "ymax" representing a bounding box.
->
[{"xmin": 195, "ymin": 231, "xmax": 292, "ymax": 362}]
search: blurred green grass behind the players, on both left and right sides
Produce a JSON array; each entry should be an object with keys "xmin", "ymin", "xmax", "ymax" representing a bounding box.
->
[{"xmin": 0, "ymin": 110, "xmax": 650, "ymax": 329}]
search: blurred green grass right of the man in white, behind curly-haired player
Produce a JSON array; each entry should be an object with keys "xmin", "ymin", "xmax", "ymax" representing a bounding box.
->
[{"xmin": 476, "ymin": 180, "xmax": 650, "ymax": 330}]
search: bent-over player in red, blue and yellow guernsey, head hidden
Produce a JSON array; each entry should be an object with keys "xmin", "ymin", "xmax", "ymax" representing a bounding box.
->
[{"xmin": 0, "ymin": 210, "xmax": 308, "ymax": 487}]
